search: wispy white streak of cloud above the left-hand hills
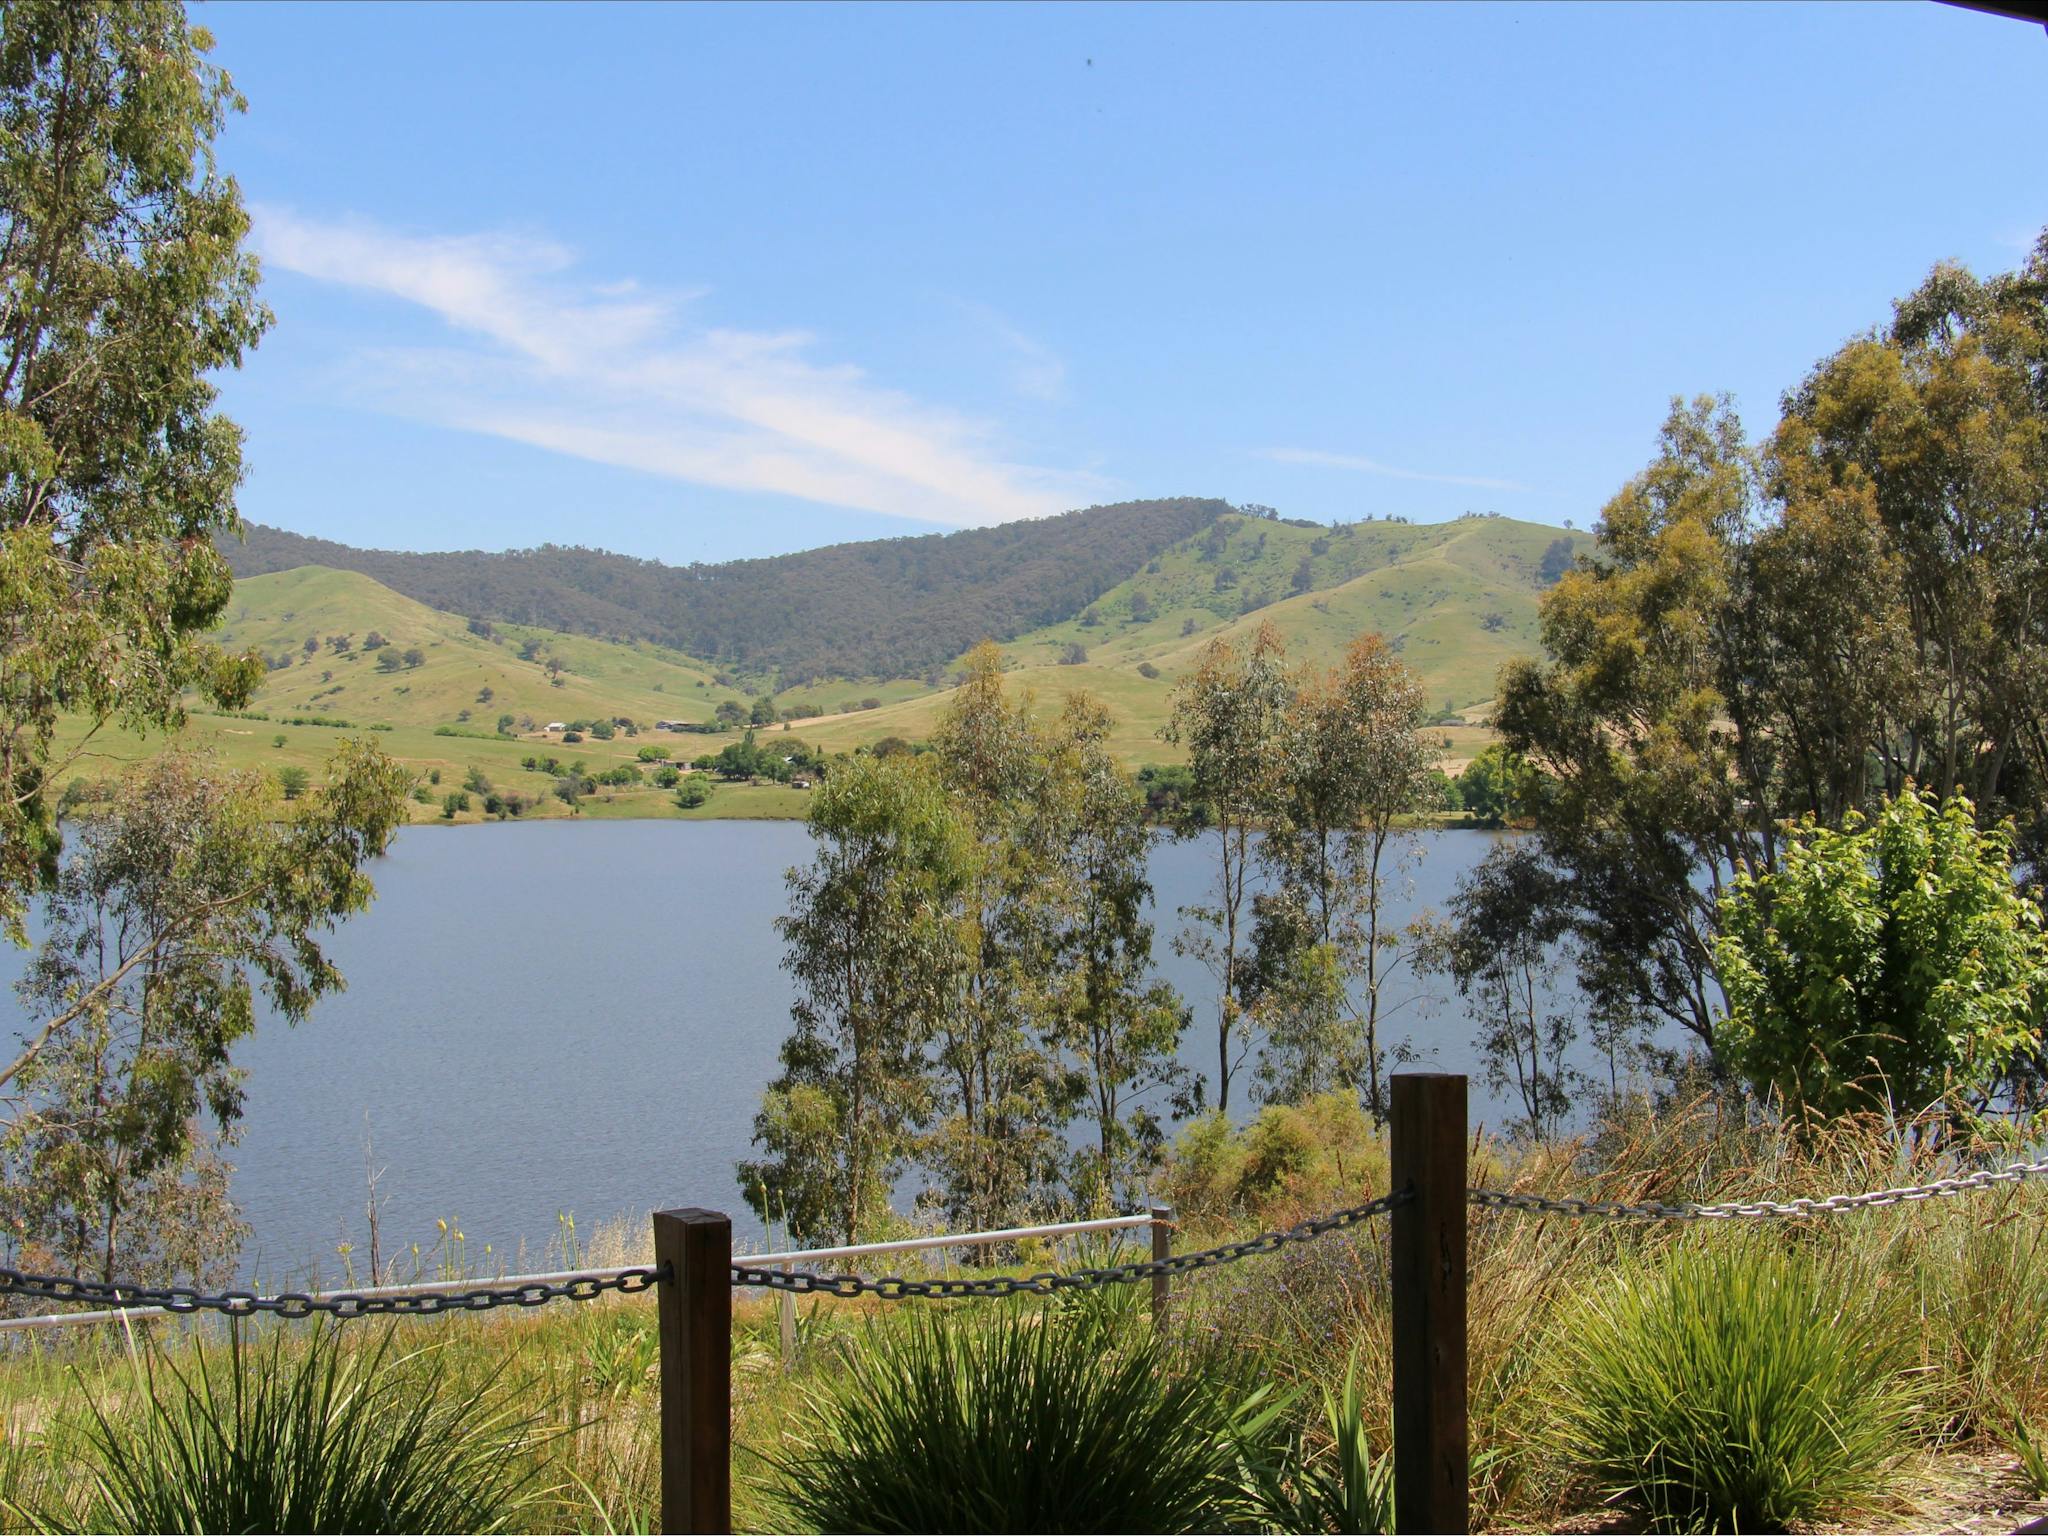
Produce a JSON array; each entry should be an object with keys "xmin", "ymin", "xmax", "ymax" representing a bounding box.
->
[{"xmin": 256, "ymin": 207, "xmax": 1104, "ymax": 526}]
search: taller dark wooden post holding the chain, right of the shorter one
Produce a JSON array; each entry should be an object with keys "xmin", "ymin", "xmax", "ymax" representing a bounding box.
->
[{"xmin": 1391, "ymin": 1071, "xmax": 1473, "ymax": 1532}]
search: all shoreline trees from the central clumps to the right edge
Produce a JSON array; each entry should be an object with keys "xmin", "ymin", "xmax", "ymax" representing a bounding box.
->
[{"xmin": 739, "ymin": 233, "xmax": 2048, "ymax": 1241}]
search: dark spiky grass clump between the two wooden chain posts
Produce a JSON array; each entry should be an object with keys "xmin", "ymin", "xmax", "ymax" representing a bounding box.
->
[{"xmin": 776, "ymin": 1311, "xmax": 1241, "ymax": 1532}]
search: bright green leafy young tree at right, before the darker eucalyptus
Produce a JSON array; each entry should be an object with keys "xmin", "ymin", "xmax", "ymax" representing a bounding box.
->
[{"xmin": 1714, "ymin": 784, "xmax": 2048, "ymax": 1116}]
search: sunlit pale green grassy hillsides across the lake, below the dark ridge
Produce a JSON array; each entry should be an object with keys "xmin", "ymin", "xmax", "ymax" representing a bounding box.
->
[{"xmin": 94, "ymin": 504, "xmax": 1589, "ymax": 819}]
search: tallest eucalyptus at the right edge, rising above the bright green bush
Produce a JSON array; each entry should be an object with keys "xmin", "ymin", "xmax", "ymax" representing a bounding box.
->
[{"xmin": 1767, "ymin": 231, "xmax": 2048, "ymax": 846}]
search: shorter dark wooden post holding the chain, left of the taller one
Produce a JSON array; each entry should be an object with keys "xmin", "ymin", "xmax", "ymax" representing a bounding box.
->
[{"xmin": 653, "ymin": 1208, "xmax": 733, "ymax": 1534}]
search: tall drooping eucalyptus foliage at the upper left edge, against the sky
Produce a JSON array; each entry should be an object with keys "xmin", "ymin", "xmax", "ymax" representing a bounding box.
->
[{"xmin": 0, "ymin": 0, "xmax": 270, "ymax": 944}]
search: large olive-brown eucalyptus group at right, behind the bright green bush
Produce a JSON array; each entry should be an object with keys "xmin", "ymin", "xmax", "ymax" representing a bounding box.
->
[{"xmin": 1497, "ymin": 231, "xmax": 2048, "ymax": 1083}]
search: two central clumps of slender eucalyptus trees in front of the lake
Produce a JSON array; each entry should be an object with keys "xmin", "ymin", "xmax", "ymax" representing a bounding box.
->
[{"xmin": 739, "ymin": 627, "xmax": 1432, "ymax": 1239}]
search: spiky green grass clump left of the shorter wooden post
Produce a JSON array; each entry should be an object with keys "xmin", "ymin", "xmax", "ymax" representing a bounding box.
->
[{"xmin": 52, "ymin": 1327, "xmax": 535, "ymax": 1532}]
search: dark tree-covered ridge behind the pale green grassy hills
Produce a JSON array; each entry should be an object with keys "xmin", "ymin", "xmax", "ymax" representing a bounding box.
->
[{"xmin": 223, "ymin": 498, "xmax": 1231, "ymax": 686}]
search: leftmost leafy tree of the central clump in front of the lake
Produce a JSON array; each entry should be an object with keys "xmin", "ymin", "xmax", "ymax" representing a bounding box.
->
[{"xmin": 739, "ymin": 756, "xmax": 975, "ymax": 1243}]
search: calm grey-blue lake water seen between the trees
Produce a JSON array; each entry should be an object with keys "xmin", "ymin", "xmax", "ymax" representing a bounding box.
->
[{"xmin": 0, "ymin": 821, "xmax": 1630, "ymax": 1282}]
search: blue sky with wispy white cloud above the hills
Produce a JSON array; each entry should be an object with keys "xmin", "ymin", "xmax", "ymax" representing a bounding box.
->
[{"xmin": 207, "ymin": 0, "xmax": 2048, "ymax": 561}]
